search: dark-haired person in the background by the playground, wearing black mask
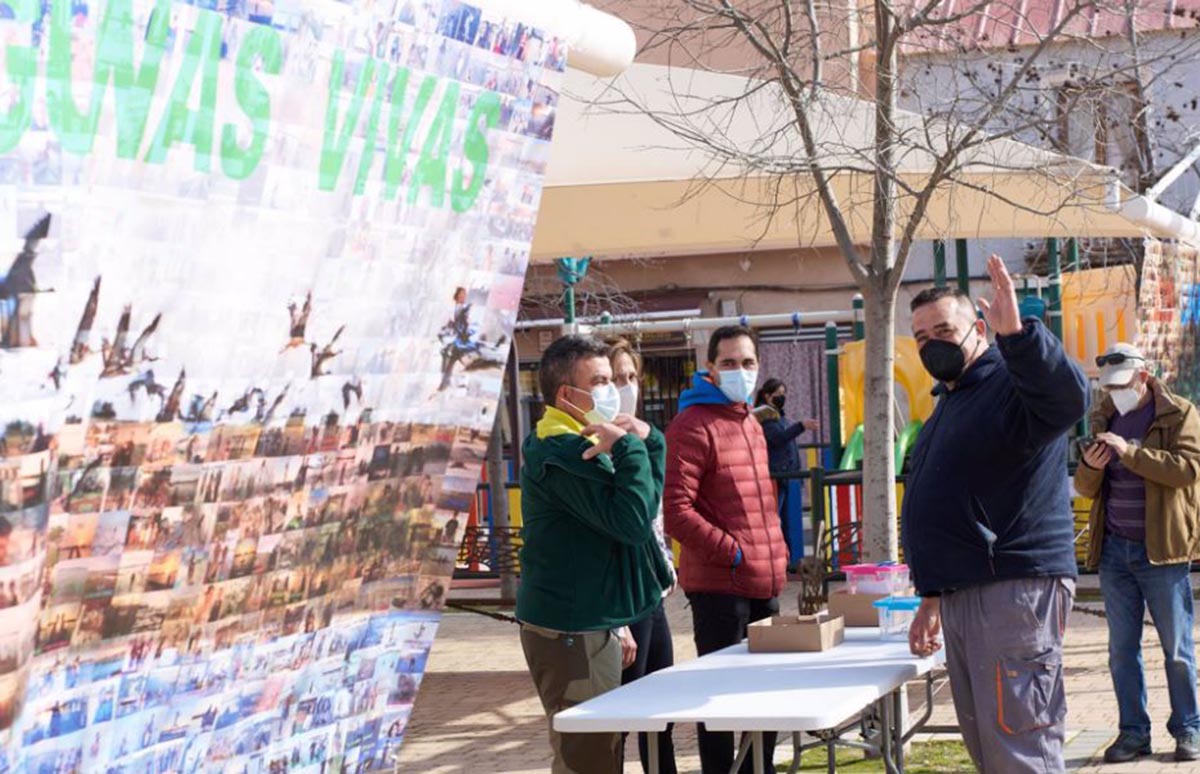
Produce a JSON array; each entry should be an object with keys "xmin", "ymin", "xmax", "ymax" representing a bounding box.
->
[{"xmin": 754, "ymin": 378, "xmax": 821, "ymax": 568}]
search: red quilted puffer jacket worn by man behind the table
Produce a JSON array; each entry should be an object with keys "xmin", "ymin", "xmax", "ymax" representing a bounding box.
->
[{"xmin": 662, "ymin": 403, "xmax": 787, "ymax": 599}]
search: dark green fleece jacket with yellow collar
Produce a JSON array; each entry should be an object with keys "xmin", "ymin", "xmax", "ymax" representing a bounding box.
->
[{"xmin": 517, "ymin": 408, "xmax": 671, "ymax": 632}]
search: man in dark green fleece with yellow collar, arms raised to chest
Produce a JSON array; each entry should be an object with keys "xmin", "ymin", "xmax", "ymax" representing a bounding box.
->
[{"xmin": 517, "ymin": 336, "xmax": 672, "ymax": 774}]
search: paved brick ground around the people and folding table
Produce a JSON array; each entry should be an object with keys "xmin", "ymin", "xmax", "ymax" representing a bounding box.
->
[{"xmin": 400, "ymin": 577, "xmax": 1200, "ymax": 774}]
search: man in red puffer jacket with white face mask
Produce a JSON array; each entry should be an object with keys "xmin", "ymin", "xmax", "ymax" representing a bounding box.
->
[{"xmin": 662, "ymin": 325, "xmax": 787, "ymax": 774}]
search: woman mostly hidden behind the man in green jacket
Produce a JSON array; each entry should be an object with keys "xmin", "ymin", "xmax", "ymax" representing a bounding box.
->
[{"xmin": 605, "ymin": 338, "xmax": 676, "ymax": 774}]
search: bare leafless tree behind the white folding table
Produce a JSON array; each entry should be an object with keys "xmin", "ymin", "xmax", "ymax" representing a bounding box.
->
[{"xmin": 601, "ymin": 0, "xmax": 1194, "ymax": 560}]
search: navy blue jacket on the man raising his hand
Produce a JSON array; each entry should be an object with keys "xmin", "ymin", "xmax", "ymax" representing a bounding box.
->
[{"xmin": 900, "ymin": 319, "xmax": 1088, "ymax": 595}]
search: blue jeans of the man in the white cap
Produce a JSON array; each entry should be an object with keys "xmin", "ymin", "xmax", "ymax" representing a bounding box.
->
[{"xmin": 1100, "ymin": 535, "xmax": 1200, "ymax": 740}]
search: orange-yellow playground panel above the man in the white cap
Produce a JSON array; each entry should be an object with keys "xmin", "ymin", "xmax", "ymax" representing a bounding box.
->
[{"xmin": 1062, "ymin": 265, "xmax": 1136, "ymax": 378}]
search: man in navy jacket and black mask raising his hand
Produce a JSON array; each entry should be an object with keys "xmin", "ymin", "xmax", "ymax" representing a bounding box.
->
[{"xmin": 901, "ymin": 256, "xmax": 1088, "ymax": 773}]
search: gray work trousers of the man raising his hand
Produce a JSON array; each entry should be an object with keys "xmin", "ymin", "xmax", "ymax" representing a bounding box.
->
[{"xmin": 941, "ymin": 578, "xmax": 1075, "ymax": 774}]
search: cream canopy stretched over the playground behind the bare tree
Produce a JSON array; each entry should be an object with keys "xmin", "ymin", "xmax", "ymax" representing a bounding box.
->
[{"xmin": 533, "ymin": 65, "xmax": 1200, "ymax": 260}]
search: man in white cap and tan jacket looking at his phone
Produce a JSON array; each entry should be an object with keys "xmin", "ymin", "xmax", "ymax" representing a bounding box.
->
[{"xmin": 1075, "ymin": 343, "xmax": 1200, "ymax": 763}]
